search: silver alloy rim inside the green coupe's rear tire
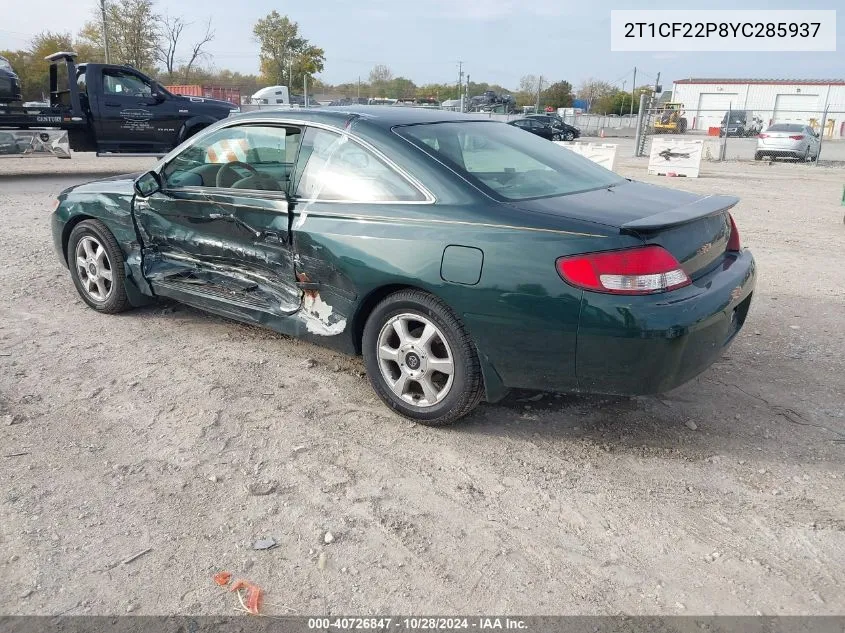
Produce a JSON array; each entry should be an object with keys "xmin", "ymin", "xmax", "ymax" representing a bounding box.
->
[{"xmin": 377, "ymin": 313, "xmax": 455, "ymax": 408}]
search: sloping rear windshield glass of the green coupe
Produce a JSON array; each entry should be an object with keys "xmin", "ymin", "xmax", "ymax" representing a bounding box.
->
[{"xmin": 394, "ymin": 121, "xmax": 624, "ymax": 200}]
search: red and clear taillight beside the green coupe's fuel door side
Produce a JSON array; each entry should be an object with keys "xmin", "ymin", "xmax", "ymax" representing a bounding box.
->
[{"xmin": 557, "ymin": 246, "xmax": 692, "ymax": 295}]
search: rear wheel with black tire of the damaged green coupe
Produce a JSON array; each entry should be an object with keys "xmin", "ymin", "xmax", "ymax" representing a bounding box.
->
[{"xmin": 362, "ymin": 290, "xmax": 483, "ymax": 426}]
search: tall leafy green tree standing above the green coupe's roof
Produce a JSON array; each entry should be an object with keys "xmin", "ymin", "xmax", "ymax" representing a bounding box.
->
[{"xmin": 252, "ymin": 11, "xmax": 325, "ymax": 85}]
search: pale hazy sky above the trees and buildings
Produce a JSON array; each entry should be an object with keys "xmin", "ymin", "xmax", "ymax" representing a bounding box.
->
[{"xmin": 0, "ymin": 0, "xmax": 845, "ymax": 90}]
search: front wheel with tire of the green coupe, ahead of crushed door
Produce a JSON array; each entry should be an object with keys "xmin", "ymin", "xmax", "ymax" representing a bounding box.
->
[{"xmin": 67, "ymin": 220, "xmax": 131, "ymax": 314}]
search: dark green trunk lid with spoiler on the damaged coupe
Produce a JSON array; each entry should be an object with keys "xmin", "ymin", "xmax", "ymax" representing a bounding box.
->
[{"xmin": 513, "ymin": 182, "xmax": 739, "ymax": 279}]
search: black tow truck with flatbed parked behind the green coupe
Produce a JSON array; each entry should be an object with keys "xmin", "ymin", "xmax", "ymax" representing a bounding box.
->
[{"xmin": 0, "ymin": 52, "xmax": 240, "ymax": 156}]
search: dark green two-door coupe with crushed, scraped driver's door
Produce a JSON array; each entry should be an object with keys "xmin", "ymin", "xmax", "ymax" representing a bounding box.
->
[{"xmin": 52, "ymin": 106, "xmax": 756, "ymax": 425}]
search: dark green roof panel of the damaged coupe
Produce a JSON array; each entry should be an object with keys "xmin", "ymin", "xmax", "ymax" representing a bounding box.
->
[{"xmin": 226, "ymin": 104, "xmax": 490, "ymax": 129}]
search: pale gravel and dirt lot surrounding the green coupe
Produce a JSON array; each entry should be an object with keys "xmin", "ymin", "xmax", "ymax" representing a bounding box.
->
[{"xmin": 0, "ymin": 148, "xmax": 845, "ymax": 614}]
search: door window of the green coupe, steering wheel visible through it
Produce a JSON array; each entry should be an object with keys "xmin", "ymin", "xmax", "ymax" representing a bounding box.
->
[{"xmin": 162, "ymin": 125, "xmax": 302, "ymax": 191}]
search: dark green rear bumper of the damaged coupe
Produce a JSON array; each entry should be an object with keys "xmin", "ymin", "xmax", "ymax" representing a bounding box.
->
[{"xmin": 576, "ymin": 251, "xmax": 756, "ymax": 395}]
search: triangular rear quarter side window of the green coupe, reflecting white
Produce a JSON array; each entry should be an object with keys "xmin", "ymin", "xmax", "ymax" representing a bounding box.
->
[{"xmin": 296, "ymin": 128, "xmax": 425, "ymax": 202}]
